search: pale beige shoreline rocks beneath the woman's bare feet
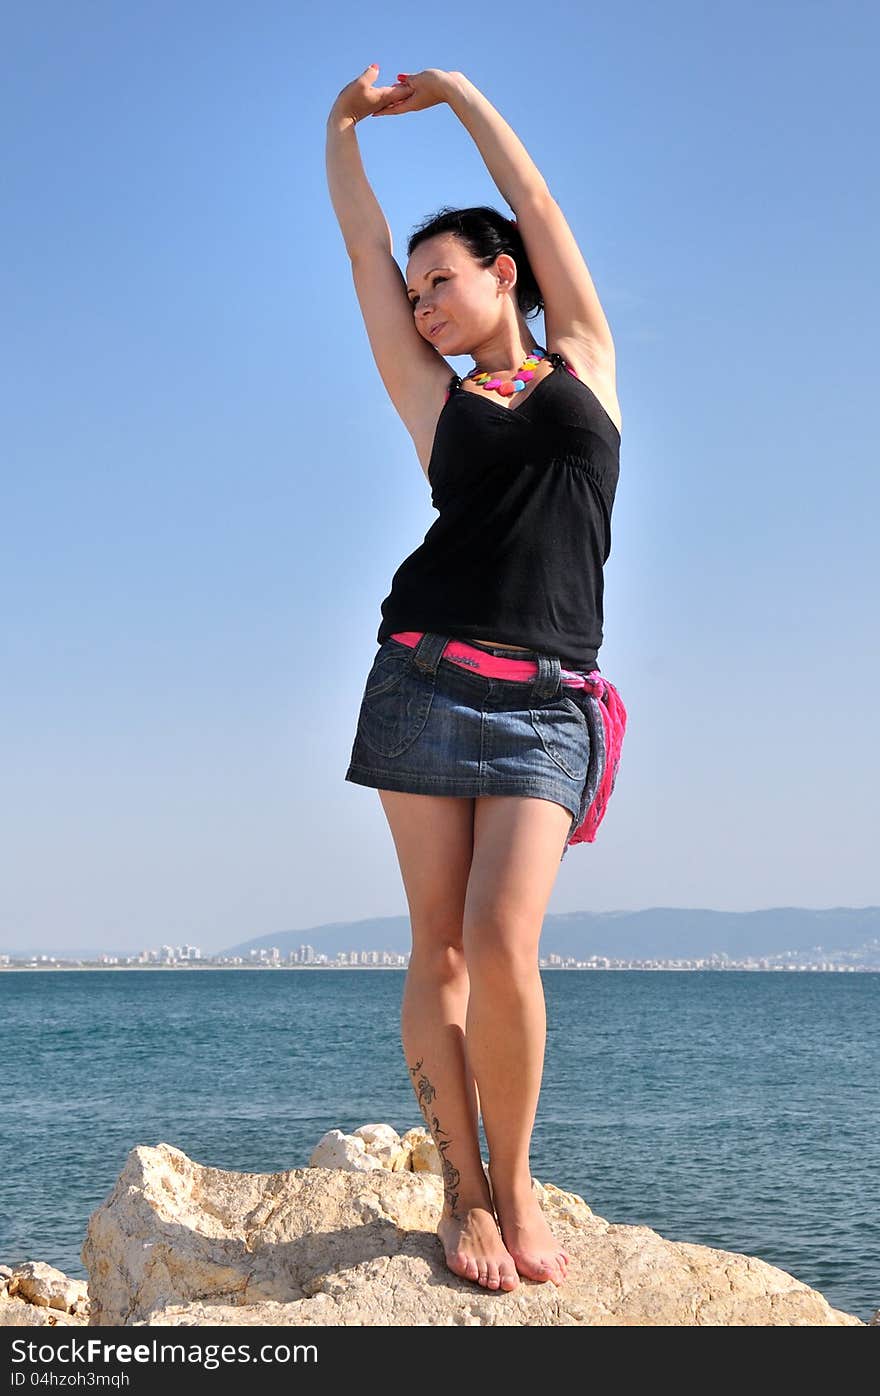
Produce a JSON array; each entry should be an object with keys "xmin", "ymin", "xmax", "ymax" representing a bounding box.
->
[{"xmin": 0, "ymin": 1124, "xmax": 880, "ymax": 1328}]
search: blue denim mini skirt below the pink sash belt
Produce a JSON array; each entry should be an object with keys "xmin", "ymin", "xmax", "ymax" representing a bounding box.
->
[{"xmin": 345, "ymin": 632, "xmax": 603, "ymax": 857}]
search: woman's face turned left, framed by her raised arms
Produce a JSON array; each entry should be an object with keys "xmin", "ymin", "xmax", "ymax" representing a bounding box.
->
[{"xmin": 406, "ymin": 233, "xmax": 515, "ymax": 355}]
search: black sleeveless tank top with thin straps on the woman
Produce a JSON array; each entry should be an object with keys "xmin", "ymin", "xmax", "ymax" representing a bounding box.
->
[{"xmin": 376, "ymin": 353, "xmax": 620, "ymax": 669}]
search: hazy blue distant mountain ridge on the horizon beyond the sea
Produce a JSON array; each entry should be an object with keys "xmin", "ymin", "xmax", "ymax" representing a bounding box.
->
[{"xmin": 214, "ymin": 906, "xmax": 880, "ymax": 965}]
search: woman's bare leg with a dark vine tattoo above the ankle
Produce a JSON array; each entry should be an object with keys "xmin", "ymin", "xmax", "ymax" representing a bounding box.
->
[{"xmin": 379, "ymin": 790, "xmax": 520, "ymax": 1290}]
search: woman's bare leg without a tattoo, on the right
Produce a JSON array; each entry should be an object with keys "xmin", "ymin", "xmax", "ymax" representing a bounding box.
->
[{"xmin": 464, "ymin": 796, "xmax": 571, "ymax": 1284}]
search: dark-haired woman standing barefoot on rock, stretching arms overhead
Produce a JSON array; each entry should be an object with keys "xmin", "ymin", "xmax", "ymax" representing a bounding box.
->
[{"xmin": 327, "ymin": 64, "xmax": 626, "ymax": 1290}]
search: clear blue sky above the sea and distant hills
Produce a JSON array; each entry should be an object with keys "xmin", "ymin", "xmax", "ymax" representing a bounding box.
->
[{"xmin": 0, "ymin": 0, "xmax": 880, "ymax": 951}]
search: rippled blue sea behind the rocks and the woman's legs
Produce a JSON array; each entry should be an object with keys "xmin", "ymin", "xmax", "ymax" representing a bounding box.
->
[{"xmin": 0, "ymin": 970, "xmax": 880, "ymax": 1319}]
